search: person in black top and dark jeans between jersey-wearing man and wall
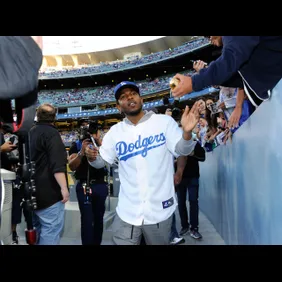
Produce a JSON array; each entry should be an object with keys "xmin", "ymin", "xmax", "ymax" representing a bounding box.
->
[{"xmin": 175, "ymin": 142, "xmax": 205, "ymax": 239}]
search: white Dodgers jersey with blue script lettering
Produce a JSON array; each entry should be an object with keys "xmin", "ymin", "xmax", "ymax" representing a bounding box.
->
[{"xmin": 100, "ymin": 113, "xmax": 183, "ymax": 226}]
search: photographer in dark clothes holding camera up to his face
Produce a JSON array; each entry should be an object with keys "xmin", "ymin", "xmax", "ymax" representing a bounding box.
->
[{"xmin": 69, "ymin": 121, "xmax": 108, "ymax": 245}]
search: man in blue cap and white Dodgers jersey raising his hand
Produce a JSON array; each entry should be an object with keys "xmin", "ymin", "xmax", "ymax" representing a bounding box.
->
[{"xmin": 86, "ymin": 81, "xmax": 199, "ymax": 245}]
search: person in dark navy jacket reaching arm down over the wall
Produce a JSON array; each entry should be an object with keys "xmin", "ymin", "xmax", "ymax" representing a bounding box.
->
[{"xmin": 172, "ymin": 36, "xmax": 282, "ymax": 106}]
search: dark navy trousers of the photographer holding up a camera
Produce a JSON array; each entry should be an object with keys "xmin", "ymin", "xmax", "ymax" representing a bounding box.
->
[{"xmin": 76, "ymin": 181, "xmax": 108, "ymax": 245}]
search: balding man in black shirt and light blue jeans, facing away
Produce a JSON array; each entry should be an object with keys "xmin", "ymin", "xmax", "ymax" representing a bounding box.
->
[{"xmin": 30, "ymin": 104, "xmax": 69, "ymax": 245}]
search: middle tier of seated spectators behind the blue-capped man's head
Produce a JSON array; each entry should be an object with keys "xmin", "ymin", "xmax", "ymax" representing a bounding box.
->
[{"xmin": 38, "ymin": 70, "xmax": 193, "ymax": 107}]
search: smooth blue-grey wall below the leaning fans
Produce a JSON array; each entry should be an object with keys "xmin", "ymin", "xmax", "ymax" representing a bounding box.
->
[{"xmin": 199, "ymin": 81, "xmax": 282, "ymax": 245}]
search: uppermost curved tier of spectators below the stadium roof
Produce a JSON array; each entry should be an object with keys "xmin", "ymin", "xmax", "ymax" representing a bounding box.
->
[{"xmin": 39, "ymin": 38, "xmax": 209, "ymax": 78}]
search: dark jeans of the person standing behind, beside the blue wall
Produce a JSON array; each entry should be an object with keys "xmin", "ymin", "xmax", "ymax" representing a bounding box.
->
[{"xmin": 176, "ymin": 178, "xmax": 199, "ymax": 231}]
